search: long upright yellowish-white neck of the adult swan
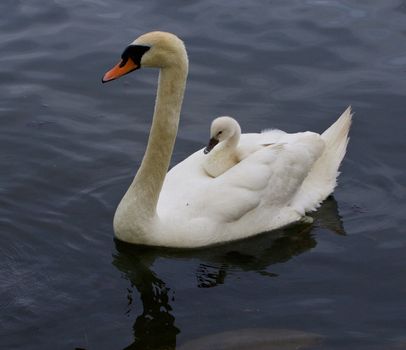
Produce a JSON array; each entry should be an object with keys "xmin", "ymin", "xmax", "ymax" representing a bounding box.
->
[{"xmin": 123, "ymin": 59, "xmax": 188, "ymax": 219}]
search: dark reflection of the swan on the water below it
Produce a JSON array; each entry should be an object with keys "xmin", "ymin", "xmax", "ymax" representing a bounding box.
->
[{"xmin": 113, "ymin": 198, "xmax": 345, "ymax": 350}]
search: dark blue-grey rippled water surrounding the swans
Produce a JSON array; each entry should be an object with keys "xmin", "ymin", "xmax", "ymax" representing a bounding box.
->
[{"xmin": 0, "ymin": 0, "xmax": 406, "ymax": 350}]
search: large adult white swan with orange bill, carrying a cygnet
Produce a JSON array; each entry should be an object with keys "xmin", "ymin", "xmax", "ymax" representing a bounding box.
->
[{"xmin": 103, "ymin": 32, "xmax": 351, "ymax": 248}]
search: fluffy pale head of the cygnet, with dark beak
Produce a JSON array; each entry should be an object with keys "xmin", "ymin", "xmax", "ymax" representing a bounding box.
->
[{"xmin": 204, "ymin": 117, "xmax": 241, "ymax": 154}]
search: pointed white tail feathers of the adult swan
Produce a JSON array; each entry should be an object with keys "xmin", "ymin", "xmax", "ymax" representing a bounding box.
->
[{"xmin": 292, "ymin": 106, "xmax": 352, "ymax": 214}]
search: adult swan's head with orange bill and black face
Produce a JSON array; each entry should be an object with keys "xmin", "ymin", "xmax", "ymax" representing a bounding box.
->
[{"xmin": 102, "ymin": 32, "xmax": 188, "ymax": 83}]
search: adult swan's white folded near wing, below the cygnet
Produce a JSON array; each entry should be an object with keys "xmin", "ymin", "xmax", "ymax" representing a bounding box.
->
[{"xmin": 157, "ymin": 133, "xmax": 324, "ymax": 225}]
